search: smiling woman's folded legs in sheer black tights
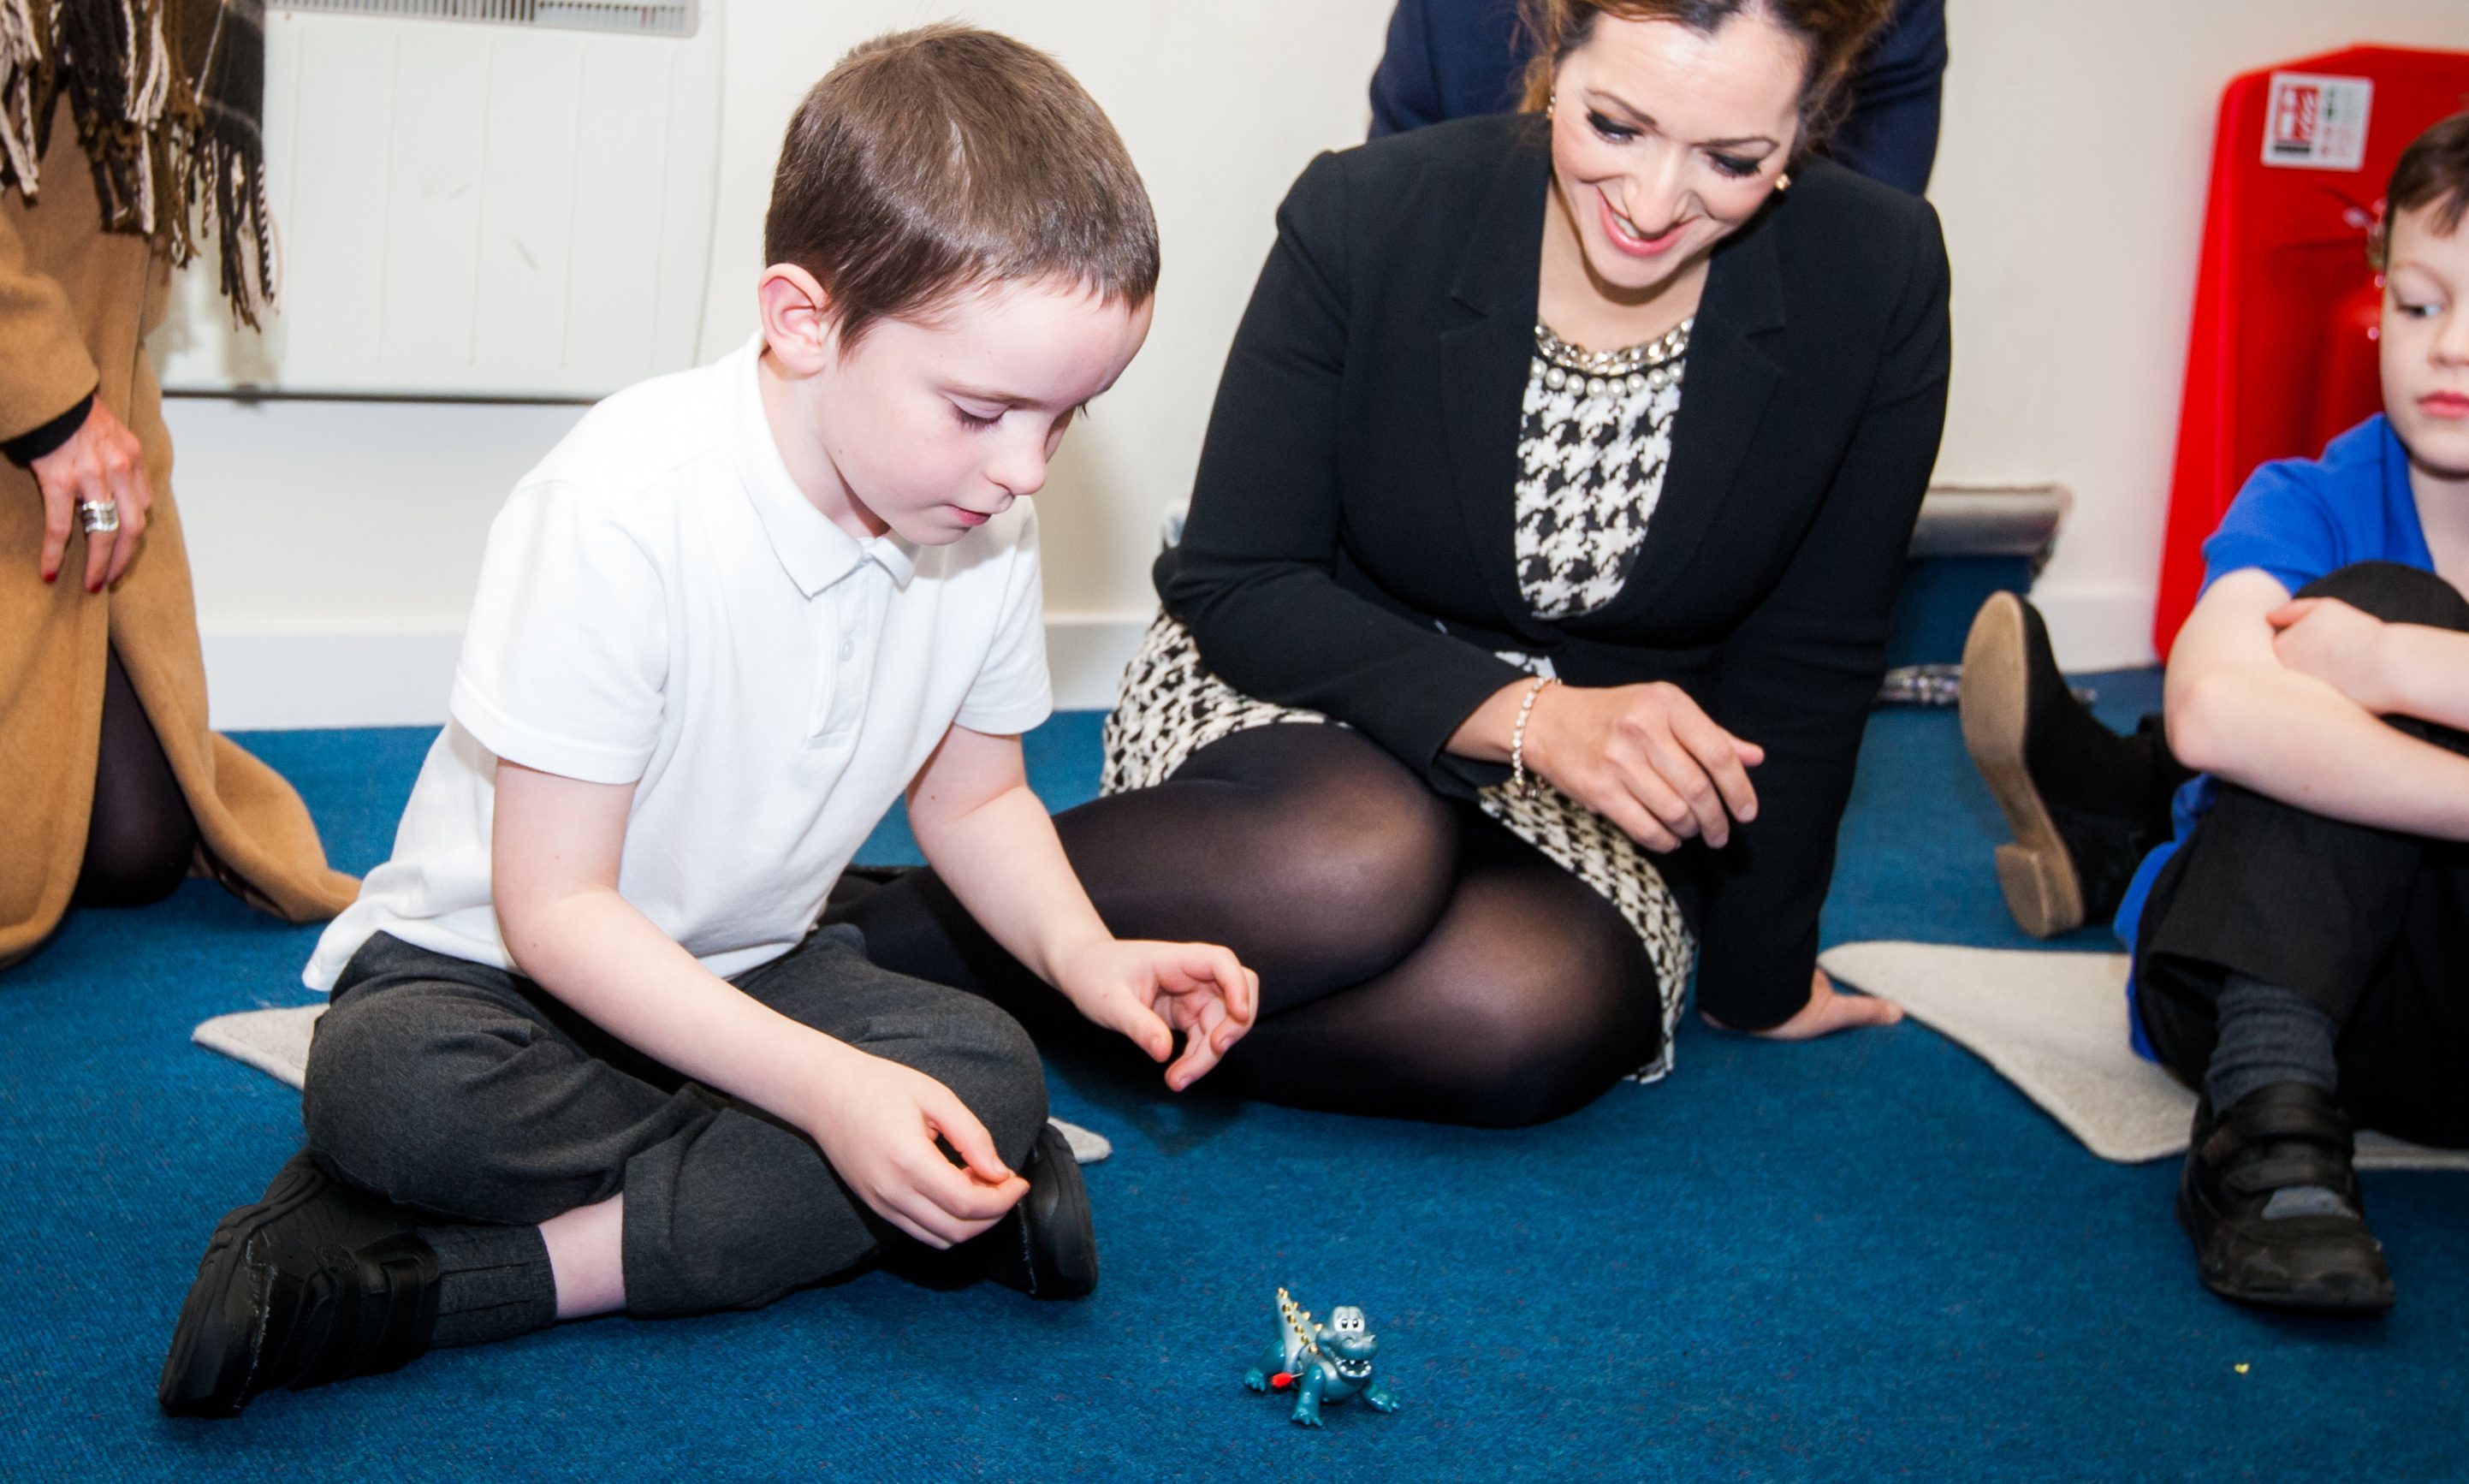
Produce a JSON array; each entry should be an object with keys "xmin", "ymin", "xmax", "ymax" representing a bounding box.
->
[{"xmin": 829, "ymin": 723, "xmax": 1662, "ymax": 1129}]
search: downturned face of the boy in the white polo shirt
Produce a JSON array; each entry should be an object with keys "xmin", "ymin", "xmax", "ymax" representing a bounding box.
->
[{"xmin": 790, "ymin": 271, "xmax": 1150, "ymax": 546}]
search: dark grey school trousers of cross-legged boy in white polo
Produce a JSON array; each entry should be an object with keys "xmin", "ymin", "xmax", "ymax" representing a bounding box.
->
[{"xmin": 301, "ymin": 926, "xmax": 1047, "ymax": 1319}]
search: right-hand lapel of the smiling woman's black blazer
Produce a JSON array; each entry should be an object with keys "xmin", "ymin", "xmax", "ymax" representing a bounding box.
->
[{"xmin": 1590, "ymin": 203, "xmax": 1783, "ymax": 622}]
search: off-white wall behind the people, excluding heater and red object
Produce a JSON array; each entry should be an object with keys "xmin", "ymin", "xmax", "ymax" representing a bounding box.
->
[{"xmin": 170, "ymin": 0, "xmax": 2469, "ymax": 726}]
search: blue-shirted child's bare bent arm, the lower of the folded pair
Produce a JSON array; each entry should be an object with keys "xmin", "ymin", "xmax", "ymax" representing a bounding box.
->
[{"xmin": 2165, "ymin": 568, "xmax": 2469, "ymax": 840}]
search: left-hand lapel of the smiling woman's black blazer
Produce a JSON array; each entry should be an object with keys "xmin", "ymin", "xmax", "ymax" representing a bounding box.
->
[{"xmin": 1439, "ymin": 120, "xmax": 1556, "ymax": 647}]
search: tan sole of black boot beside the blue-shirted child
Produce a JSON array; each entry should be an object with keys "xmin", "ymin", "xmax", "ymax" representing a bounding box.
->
[{"xmin": 1956, "ymin": 592, "xmax": 2084, "ymax": 938}]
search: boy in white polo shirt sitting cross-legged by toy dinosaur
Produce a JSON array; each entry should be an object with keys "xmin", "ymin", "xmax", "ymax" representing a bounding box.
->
[{"xmin": 158, "ymin": 27, "xmax": 1256, "ymax": 1415}]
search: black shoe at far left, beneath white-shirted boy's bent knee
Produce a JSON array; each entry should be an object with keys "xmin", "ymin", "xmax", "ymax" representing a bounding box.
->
[{"xmin": 156, "ymin": 1150, "xmax": 437, "ymax": 1417}]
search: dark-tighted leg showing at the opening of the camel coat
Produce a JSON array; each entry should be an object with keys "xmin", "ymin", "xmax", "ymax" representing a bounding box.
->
[{"xmin": 72, "ymin": 652, "xmax": 198, "ymax": 906}]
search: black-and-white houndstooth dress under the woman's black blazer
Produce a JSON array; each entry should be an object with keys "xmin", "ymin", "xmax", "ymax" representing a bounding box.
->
[{"xmin": 1099, "ymin": 321, "xmax": 1696, "ymax": 1082}]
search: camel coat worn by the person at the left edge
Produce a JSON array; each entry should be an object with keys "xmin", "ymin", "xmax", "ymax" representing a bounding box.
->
[{"xmin": 0, "ymin": 106, "xmax": 358, "ymax": 965}]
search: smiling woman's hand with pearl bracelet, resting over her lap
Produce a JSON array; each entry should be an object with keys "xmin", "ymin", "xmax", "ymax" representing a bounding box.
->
[{"xmin": 1526, "ymin": 681, "xmax": 1766, "ymax": 852}]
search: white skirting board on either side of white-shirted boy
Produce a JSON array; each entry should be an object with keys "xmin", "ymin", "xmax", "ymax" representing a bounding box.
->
[{"xmin": 203, "ymin": 613, "xmax": 1150, "ymax": 731}]
